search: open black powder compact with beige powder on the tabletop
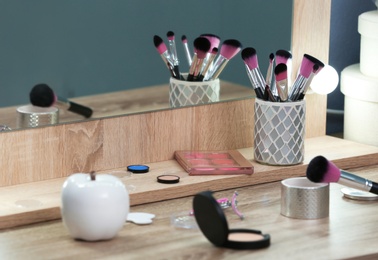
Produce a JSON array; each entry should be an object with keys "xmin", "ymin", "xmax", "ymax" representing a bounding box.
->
[{"xmin": 193, "ymin": 191, "xmax": 270, "ymax": 249}]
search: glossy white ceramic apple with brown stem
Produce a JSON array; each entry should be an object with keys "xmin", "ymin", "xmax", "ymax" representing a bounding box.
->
[{"xmin": 61, "ymin": 173, "xmax": 130, "ymax": 241}]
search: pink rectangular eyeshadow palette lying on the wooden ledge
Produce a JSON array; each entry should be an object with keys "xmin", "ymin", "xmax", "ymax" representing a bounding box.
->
[{"xmin": 175, "ymin": 150, "xmax": 253, "ymax": 175}]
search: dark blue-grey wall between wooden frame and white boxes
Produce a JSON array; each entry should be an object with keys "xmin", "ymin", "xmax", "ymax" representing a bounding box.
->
[{"xmin": 327, "ymin": 0, "xmax": 377, "ymax": 134}]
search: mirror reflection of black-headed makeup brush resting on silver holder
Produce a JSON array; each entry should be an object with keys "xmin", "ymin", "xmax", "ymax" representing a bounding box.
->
[{"xmin": 29, "ymin": 83, "xmax": 93, "ymax": 118}]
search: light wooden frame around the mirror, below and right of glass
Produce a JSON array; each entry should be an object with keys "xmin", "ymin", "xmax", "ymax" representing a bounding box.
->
[{"xmin": 0, "ymin": 0, "xmax": 331, "ymax": 187}]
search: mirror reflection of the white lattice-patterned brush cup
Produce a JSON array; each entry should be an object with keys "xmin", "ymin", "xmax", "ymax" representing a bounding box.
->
[{"xmin": 169, "ymin": 75, "xmax": 220, "ymax": 108}]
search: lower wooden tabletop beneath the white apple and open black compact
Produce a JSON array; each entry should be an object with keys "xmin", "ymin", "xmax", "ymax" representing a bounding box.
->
[{"xmin": 0, "ymin": 165, "xmax": 378, "ymax": 259}]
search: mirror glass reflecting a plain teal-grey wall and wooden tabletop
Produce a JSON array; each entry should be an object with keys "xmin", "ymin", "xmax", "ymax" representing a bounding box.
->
[{"xmin": 0, "ymin": 0, "xmax": 293, "ymax": 130}]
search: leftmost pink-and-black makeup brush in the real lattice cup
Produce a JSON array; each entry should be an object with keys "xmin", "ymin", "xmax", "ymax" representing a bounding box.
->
[{"xmin": 241, "ymin": 47, "xmax": 265, "ymax": 99}]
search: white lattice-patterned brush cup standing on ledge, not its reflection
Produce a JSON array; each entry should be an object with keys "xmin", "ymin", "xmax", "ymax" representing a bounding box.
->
[{"xmin": 254, "ymin": 98, "xmax": 306, "ymax": 165}]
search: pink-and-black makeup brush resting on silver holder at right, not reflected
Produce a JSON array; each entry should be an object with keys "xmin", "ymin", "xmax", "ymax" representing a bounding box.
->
[{"xmin": 306, "ymin": 155, "xmax": 378, "ymax": 194}]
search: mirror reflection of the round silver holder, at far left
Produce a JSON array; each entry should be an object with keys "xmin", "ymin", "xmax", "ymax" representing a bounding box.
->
[{"xmin": 17, "ymin": 105, "xmax": 59, "ymax": 128}]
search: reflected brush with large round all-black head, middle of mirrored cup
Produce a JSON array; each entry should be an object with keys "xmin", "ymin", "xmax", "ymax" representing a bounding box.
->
[{"xmin": 187, "ymin": 37, "xmax": 211, "ymax": 81}]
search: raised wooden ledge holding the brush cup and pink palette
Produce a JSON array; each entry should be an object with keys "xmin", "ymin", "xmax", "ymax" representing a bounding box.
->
[{"xmin": 0, "ymin": 136, "xmax": 378, "ymax": 229}]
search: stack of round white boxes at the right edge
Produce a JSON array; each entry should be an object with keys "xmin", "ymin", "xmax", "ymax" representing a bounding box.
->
[{"xmin": 340, "ymin": 5, "xmax": 378, "ymax": 146}]
